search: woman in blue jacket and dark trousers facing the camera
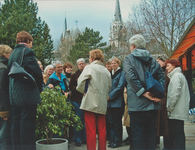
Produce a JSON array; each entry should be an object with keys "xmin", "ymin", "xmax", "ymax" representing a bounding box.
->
[{"xmin": 108, "ymin": 57, "xmax": 126, "ymax": 148}]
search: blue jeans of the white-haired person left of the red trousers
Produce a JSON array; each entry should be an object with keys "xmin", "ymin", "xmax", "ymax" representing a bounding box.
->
[{"xmin": 73, "ymin": 102, "xmax": 86, "ymax": 143}]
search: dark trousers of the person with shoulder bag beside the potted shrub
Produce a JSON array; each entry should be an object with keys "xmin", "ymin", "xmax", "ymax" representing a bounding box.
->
[{"xmin": 11, "ymin": 105, "xmax": 37, "ymax": 150}]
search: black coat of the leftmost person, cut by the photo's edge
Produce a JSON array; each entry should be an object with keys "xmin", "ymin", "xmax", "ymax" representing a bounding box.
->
[{"xmin": 0, "ymin": 57, "xmax": 10, "ymax": 112}]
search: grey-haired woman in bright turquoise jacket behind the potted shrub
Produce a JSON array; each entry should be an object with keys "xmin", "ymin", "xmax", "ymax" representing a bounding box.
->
[{"xmin": 46, "ymin": 60, "xmax": 69, "ymax": 97}]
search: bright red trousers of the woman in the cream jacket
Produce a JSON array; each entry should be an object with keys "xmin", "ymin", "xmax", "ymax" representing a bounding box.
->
[{"xmin": 84, "ymin": 111, "xmax": 106, "ymax": 150}]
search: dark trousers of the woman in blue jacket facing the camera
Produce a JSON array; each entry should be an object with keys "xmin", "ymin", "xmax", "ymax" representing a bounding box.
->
[{"xmin": 107, "ymin": 108, "xmax": 123, "ymax": 145}]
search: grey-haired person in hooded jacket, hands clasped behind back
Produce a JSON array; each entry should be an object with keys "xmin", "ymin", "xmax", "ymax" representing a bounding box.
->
[{"xmin": 123, "ymin": 34, "xmax": 165, "ymax": 150}]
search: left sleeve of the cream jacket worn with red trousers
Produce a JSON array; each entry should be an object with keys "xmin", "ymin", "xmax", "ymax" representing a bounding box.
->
[{"xmin": 76, "ymin": 65, "xmax": 91, "ymax": 93}]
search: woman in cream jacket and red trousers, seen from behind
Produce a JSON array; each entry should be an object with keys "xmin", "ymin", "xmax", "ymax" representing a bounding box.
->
[{"xmin": 77, "ymin": 49, "xmax": 111, "ymax": 150}]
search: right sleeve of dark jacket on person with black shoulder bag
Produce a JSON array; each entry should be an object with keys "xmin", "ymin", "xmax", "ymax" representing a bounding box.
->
[{"xmin": 23, "ymin": 49, "xmax": 43, "ymax": 92}]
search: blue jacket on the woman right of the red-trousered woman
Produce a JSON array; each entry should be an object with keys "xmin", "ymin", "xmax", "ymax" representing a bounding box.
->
[{"xmin": 108, "ymin": 69, "xmax": 126, "ymax": 108}]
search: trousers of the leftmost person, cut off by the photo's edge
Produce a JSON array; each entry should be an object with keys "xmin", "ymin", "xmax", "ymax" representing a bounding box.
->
[{"xmin": 0, "ymin": 117, "xmax": 12, "ymax": 150}]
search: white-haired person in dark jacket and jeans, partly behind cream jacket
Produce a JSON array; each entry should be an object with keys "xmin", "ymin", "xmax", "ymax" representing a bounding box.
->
[{"xmin": 69, "ymin": 58, "xmax": 86, "ymax": 146}]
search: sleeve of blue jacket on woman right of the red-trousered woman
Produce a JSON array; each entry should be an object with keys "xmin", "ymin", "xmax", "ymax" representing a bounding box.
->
[{"xmin": 108, "ymin": 71, "xmax": 126, "ymax": 100}]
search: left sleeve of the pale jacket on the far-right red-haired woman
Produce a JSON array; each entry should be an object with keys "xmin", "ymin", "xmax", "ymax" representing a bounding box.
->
[{"xmin": 167, "ymin": 76, "xmax": 182, "ymax": 112}]
